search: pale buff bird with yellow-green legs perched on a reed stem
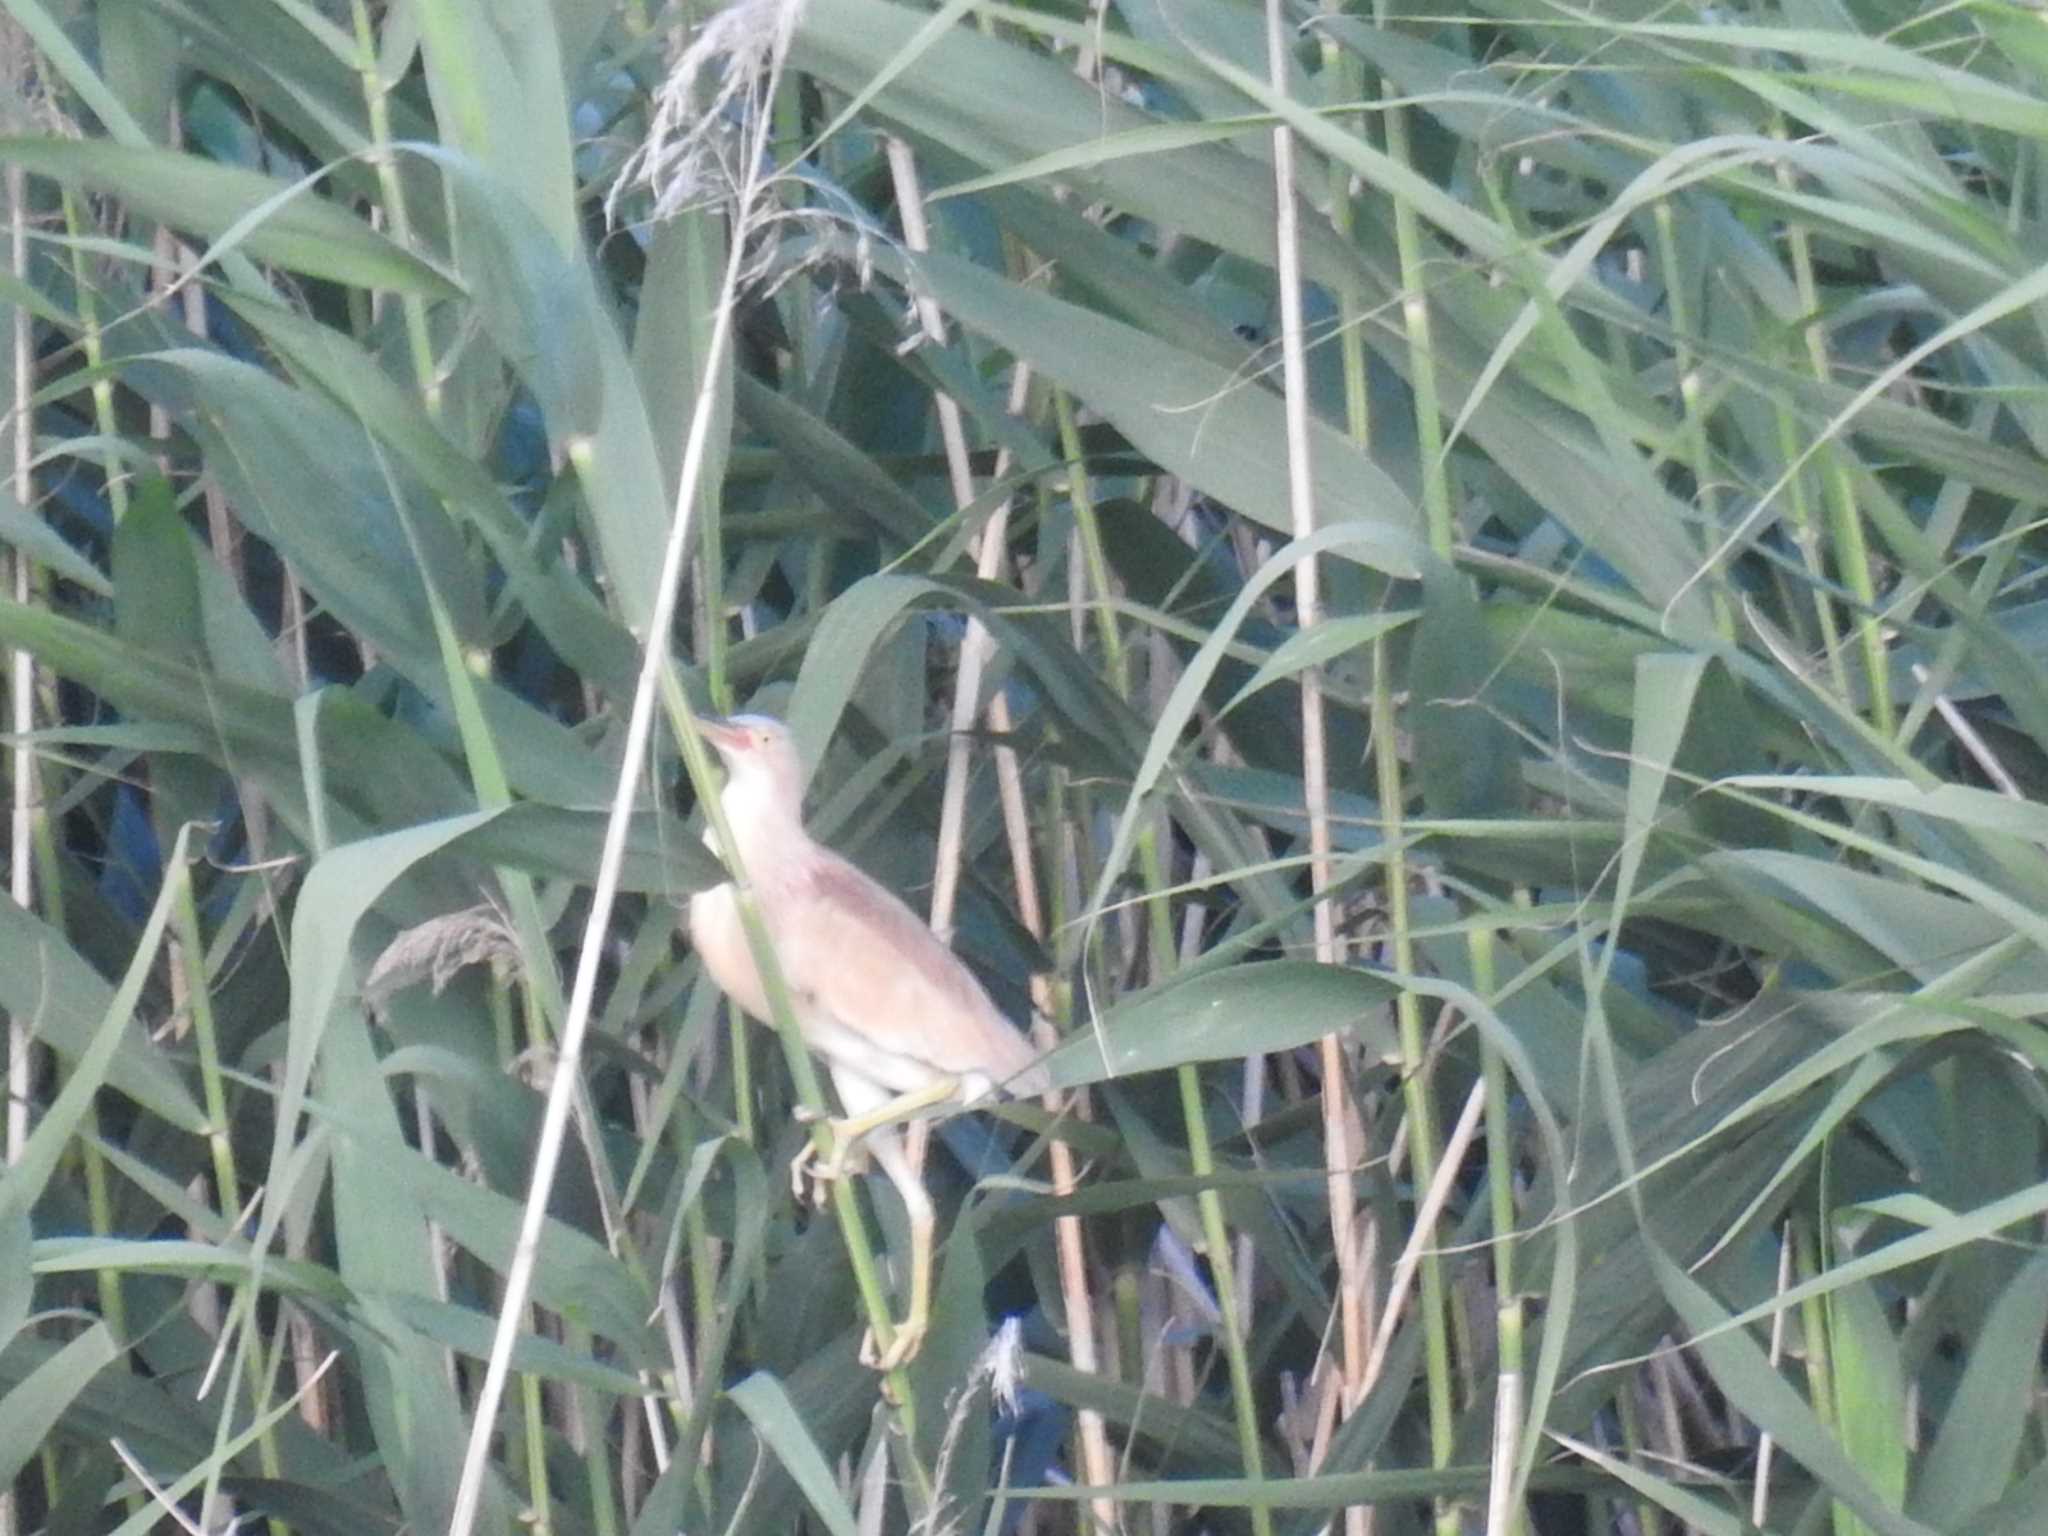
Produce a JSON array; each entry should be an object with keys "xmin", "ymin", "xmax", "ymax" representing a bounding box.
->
[{"xmin": 688, "ymin": 715, "xmax": 1053, "ymax": 1370}]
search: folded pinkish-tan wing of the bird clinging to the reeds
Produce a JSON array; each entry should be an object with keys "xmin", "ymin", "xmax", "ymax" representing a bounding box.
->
[{"xmin": 764, "ymin": 848, "xmax": 1038, "ymax": 1092}]
